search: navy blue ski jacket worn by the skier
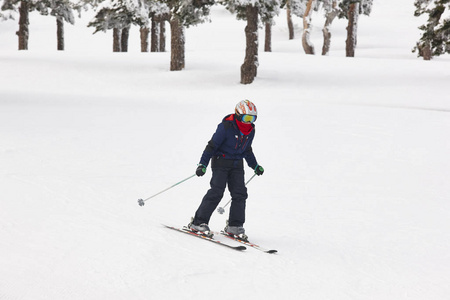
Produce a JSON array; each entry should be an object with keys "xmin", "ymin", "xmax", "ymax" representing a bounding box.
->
[{"xmin": 200, "ymin": 114, "xmax": 258, "ymax": 169}]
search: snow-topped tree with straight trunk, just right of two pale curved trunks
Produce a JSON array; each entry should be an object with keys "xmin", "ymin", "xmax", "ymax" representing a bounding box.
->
[{"xmin": 339, "ymin": 0, "xmax": 373, "ymax": 57}]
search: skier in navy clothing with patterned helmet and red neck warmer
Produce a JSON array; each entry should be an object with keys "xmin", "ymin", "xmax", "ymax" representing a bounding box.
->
[{"xmin": 188, "ymin": 100, "xmax": 264, "ymax": 239}]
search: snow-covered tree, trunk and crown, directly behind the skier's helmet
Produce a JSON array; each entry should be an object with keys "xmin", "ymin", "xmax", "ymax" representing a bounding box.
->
[{"xmin": 222, "ymin": 0, "xmax": 280, "ymax": 84}]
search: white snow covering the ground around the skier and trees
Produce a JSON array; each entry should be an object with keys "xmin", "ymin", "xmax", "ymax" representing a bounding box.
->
[{"xmin": 0, "ymin": 0, "xmax": 450, "ymax": 300}]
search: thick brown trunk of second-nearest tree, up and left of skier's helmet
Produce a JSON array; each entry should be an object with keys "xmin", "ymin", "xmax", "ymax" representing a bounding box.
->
[{"xmin": 170, "ymin": 16, "xmax": 185, "ymax": 71}]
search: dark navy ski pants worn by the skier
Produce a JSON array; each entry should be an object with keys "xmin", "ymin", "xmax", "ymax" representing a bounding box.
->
[{"xmin": 194, "ymin": 160, "xmax": 248, "ymax": 226}]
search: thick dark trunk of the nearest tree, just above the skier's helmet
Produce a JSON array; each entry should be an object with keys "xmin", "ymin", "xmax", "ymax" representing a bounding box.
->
[{"xmin": 241, "ymin": 5, "xmax": 258, "ymax": 84}]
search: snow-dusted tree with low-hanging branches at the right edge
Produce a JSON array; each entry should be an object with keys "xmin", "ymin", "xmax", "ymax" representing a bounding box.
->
[{"xmin": 413, "ymin": 0, "xmax": 450, "ymax": 60}]
